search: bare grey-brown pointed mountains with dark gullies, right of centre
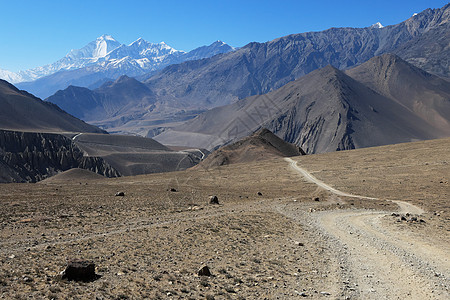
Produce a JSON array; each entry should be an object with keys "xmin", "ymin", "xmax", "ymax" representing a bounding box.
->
[{"xmin": 155, "ymin": 55, "xmax": 450, "ymax": 153}]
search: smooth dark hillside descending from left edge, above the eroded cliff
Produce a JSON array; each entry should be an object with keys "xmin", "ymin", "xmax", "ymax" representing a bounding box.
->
[{"xmin": 0, "ymin": 80, "xmax": 104, "ymax": 133}]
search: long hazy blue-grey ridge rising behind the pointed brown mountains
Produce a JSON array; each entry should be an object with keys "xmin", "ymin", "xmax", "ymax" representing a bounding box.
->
[{"xmin": 146, "ymin": 4, "xmax": 450, "ymax": 108}]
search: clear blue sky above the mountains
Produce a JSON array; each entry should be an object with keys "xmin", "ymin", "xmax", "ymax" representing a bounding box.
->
[{"xmin": 0, "ymin": 0, "xmax": 448, "ymax": 71}]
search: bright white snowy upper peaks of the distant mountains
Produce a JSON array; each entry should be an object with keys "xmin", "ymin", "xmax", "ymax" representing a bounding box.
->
[{"xmin": 0, "ymin": 34, "xmax": 234, "ymax": 83}]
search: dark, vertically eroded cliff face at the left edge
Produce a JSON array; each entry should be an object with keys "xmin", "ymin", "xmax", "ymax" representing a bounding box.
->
[{"xmin": 0, "ymin": 130, "xmax": 120, "ymax": 182}]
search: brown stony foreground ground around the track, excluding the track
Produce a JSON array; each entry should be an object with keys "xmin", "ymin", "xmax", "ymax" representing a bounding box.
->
[{"xmin": 0, "ymin": 140, "xmax": 450, "ymax": 299}]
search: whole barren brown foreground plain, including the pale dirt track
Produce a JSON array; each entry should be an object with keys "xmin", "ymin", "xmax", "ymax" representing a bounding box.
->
[{"xmin": 0, "ymin": 139, "xmax": 450, "ymax": 299}]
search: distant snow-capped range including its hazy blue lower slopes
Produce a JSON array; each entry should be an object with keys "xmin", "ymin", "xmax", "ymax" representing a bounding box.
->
[{"xmin": 0, "ymin": 35, "xmax": 234, "ymax": 98}]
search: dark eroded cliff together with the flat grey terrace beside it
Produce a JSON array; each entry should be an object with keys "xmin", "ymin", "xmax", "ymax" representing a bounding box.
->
[{"xmin": 0, "ymin": 130, "xmax": 205, "ymax": 183}]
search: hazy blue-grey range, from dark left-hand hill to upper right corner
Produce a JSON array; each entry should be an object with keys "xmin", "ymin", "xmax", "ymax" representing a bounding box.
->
[{"xmin": 47, "ymin": 4, "xmax": 450, "ymax": 141}]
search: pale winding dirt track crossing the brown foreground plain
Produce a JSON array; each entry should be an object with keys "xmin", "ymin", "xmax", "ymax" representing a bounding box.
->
[{"xmin": 281, "ymin": 158, "xmax": 450, "ymax": 299}]
